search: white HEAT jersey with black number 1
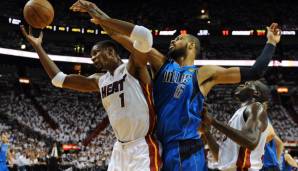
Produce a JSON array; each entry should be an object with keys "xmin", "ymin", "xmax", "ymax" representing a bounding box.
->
[{"xmin": 99, "ymin": 64, "xmax": 154, "ymax": 142}]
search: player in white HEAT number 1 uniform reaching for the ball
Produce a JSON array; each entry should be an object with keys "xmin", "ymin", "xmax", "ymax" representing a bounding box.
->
[{"xmin": 21, "ymin": 17, "xmax": 161, "ymax": 171}]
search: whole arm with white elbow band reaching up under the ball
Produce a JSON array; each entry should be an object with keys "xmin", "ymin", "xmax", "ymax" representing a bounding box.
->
[{"xmin": 21, "ymin": 26, "xmax": 99, "ymax": 92}]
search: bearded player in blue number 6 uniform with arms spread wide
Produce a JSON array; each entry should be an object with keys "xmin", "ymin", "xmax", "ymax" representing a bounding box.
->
[{"xmin": 69, "ymin": 0, "xmax": 280, "ymax": 171}]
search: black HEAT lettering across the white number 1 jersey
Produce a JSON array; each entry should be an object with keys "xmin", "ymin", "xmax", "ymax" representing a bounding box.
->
[{"xmin": 101, "ymin": 74, "xmax": 126, "ymax": 98}]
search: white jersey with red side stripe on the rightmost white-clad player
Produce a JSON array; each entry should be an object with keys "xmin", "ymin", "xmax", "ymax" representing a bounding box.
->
[{"xmin": 218, "ymin": 106, "xmax": 268, "ymax": 171}]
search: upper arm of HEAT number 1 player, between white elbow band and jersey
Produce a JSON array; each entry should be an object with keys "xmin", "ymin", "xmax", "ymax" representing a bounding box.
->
[{"xmin": 63, "ymin": 74, "xmax": 99, "ymax": 92}]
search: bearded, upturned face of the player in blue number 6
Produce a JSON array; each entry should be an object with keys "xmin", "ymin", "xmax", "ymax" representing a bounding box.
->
[{"xmin": 168, "ymin": 35, "xmax": 187, "ymax": 59}]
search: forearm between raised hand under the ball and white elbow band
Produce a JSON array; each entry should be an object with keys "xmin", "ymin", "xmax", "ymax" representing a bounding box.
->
[{"xmin": 34, "ymin": 45, "xmax": 60, "ymax": 79}]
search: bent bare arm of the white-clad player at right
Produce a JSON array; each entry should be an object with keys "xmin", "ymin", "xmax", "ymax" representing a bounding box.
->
[{"xmin": 204, "ymin": 103, "xmax": 267, "ymax": 150}]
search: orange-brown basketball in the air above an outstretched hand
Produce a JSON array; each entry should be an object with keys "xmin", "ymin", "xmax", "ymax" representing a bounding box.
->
[{"xmin": 23, "ymin": 0, "xmax": 54, "ymax": 29}]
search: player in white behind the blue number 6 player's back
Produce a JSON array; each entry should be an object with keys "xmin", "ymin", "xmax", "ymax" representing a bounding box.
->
[{"xmin": 203, "ymin": 81, "xmax": 270, "ymax": 171}]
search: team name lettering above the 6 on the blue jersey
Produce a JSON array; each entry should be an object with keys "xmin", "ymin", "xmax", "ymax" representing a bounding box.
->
[{"xmin": 163, "ymin": 71, "xmax": 192, "ymax": 84}]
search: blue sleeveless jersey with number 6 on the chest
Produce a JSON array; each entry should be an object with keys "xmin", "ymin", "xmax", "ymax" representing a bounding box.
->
[{"xmin": 153, "ymin": 59, "xmax": 204, "ymax": 144}]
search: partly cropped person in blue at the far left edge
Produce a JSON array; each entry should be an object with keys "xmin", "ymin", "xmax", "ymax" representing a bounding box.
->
[{"xmin": 0, "ymin": 132, "xmax": 13, "ymax": 171}]
